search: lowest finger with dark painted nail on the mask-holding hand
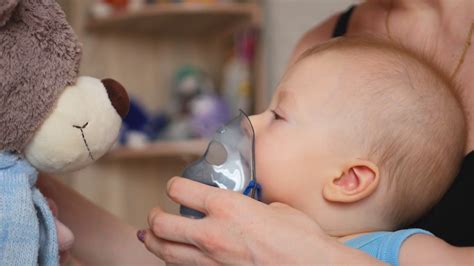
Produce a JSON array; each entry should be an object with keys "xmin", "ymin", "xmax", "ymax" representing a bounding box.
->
[{"xmin": 143, "ymin": 230, "xmax": 218, "ymax": 265}]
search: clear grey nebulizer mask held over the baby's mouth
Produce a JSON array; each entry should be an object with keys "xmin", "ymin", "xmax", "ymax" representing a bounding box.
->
[{"xmin": 180, "ymin": 111, "xmax": 261, "ymax": 218}]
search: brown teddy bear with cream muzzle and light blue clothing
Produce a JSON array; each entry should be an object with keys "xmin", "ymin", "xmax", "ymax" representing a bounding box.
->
[{"xmin": 0, "ymin": 0, "xmax": 129, "ymax": 265}]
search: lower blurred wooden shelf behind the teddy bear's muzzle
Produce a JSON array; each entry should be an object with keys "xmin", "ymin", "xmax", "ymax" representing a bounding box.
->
[{"xmin": 103, "ymin": 139, "xmax": 209, "ymax": 161}]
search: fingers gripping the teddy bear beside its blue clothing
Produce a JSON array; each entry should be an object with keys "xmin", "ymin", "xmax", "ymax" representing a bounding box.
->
[{"xmin": 46, "ymin": 198, "xmax": 74, "ymax": 265}]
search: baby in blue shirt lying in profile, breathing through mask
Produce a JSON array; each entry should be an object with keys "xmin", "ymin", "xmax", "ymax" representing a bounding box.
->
[{"xmin": 251, "ymin": 37, "xmax": 466, "ymax": 265}]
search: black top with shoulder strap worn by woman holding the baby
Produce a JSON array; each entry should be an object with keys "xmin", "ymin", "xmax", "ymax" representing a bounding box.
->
[{"xmin": 332, "ymin": 6, "xmax": 474, "ymax": 246}]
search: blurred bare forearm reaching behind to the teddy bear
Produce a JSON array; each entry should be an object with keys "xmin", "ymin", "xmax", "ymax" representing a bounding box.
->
[{"xmin": 38, "ymin": 174, "xmax": 163, "ymax": 265}]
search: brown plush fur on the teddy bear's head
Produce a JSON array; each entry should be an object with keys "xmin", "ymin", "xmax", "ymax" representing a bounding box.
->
[{"xmin": 0, "ymin": 0, "xmax": 81, "ymax": 152}]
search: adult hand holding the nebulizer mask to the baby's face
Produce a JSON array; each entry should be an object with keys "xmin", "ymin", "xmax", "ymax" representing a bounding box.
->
[{"xmin": 139, "ymin": 177, "xmax": 370, "ymax": 265}]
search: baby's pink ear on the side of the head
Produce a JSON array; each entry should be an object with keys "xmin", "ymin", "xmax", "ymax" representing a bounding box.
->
[{"xmin": 323, "ymin": 160, "xmax": 380, "ymax": 203}]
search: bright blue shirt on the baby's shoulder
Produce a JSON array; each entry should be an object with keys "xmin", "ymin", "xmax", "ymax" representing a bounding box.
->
[{"xmin": 345, "ymin": 229, "xmax": 432, "ymax": 266}]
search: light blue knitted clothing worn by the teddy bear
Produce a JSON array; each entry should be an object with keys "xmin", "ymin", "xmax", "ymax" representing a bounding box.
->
[{"xmin": 0, "ymin": 152, "xmax": 59, "ymax": 266}]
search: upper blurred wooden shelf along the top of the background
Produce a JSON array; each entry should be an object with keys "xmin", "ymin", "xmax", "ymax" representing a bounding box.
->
[{"xmin": 86, "ymin": 3, "xmax": 260, "ymax": 35}]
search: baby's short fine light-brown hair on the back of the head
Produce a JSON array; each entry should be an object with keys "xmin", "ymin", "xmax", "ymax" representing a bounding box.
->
[{"xmin": 296, "ymin": 36, "xmax": 466, "ymax": 227}]
